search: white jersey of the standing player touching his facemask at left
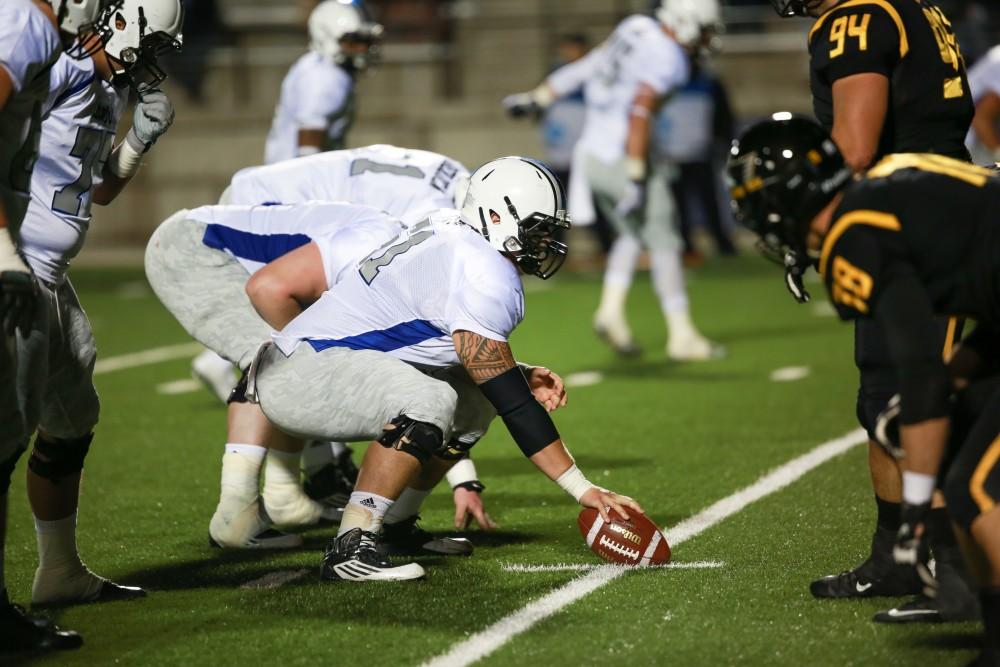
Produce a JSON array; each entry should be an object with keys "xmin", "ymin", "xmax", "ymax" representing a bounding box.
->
[{"xmin": 21, "ymin": 54, "xmax": 128, "ymax": 285}]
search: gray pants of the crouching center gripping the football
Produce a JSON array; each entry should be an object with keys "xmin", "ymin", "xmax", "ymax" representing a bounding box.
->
[{"xmin": 255, "ymin": 342, "xmax": 496, "ymax": 446}]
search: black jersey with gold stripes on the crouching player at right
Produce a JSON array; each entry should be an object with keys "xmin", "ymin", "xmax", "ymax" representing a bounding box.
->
[{"xmin": 819, "ymin": 153, "xmax": 1000, "ymax": 324}]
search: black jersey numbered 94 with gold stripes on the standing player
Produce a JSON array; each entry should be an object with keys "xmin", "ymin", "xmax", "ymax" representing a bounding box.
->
[{"xmin": 809, "ymin": 0, "xmax": 975, "ymax": 159}]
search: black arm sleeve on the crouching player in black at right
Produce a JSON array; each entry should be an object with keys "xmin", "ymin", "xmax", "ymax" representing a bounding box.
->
[{"xmin": 874, "ymin": 264, "xmax": 951, "ymax": 424}]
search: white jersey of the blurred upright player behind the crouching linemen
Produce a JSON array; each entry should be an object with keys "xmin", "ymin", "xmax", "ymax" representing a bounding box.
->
[{"xmin": 264, "ymin": 51, "xmax": 354, "ymax": 164}]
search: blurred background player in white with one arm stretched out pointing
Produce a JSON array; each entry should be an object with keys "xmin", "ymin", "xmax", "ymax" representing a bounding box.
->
[{"xmin": 504, "ymin": 0, "xmax": 722, "ymax": 360}]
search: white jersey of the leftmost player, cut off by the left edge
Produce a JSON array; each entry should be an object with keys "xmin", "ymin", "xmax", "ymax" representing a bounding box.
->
[{"xmin": 0, "ymin": 0, "xmax": 62, "ymax": 235}]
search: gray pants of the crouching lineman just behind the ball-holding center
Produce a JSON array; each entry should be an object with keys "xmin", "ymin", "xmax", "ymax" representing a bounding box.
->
[{"xmin": 146, "ymin": 211, "xmax": 271, "ymax": 368}]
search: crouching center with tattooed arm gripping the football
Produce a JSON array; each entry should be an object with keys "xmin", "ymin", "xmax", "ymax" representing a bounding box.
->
[{"xmin": 238, "ymin": 157, "xmax": 642, "ymax": 581}]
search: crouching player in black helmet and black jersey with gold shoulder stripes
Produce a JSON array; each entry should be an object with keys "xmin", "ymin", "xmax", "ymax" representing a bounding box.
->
[{"xmin": 729, "ymin": 116, "xmax": 1000, "ymax": 667}]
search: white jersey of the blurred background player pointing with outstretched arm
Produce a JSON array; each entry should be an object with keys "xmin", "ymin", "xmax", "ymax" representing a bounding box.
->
[{"xmin": 547, "ymin": 15, "xmax": 689, "ymax": 164}]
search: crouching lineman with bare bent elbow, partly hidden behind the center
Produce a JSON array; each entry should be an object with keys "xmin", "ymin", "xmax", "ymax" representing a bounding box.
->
[{"xmin": 146, "ymin": 202, "xmax": 403, "ymax": 548}]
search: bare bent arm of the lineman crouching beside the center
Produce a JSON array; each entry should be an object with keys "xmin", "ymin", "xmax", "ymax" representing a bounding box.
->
[{"xmin": 246, "ymin": 243, "xmax": 327, "ymax": 330}]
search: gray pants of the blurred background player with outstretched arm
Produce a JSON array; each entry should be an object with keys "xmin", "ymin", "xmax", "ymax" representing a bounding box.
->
[{"xmin": 584, "ymin": 155, "xmax": 681, "ymax": 252}]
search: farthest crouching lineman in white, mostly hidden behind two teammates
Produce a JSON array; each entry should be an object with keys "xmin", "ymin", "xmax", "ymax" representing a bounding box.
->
[{"xmin": 192, "ymin": 145, "xmax": 493, "ymax": 547}]
